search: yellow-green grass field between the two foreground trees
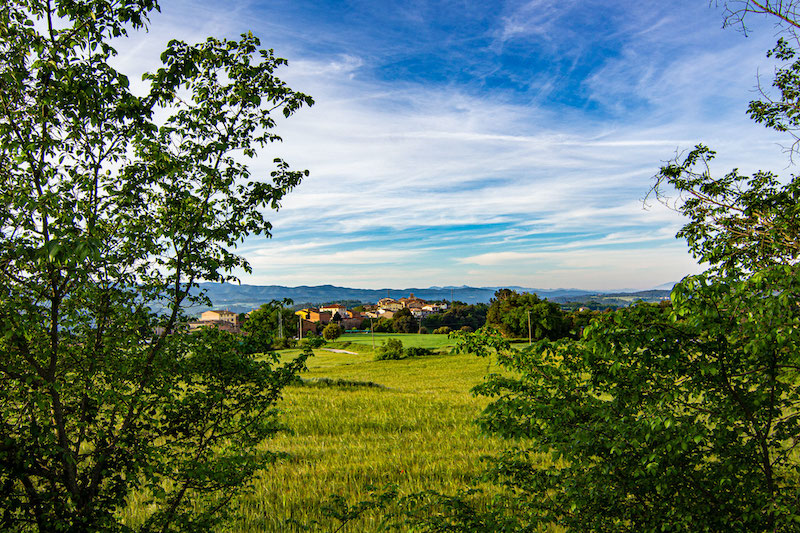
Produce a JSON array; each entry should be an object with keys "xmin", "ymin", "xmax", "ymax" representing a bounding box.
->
[{"xmin": 231, "ymin": 334, "xmax": 510, "ymax": 532}]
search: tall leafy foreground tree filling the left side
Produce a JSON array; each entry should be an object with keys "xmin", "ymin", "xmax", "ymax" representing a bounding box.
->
[{"xmin": 0, "ymin": 0, "xmax": 312, "ymax": 531}]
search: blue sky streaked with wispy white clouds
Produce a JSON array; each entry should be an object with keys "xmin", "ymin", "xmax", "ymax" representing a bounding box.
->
[{"xmin": 116, "ymin": 0, "xmax": 792, "ymax": 290}]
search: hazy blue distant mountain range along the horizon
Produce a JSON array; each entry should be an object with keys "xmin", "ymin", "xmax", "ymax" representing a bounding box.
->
[{"xmin": 192, "ymin": 283, "xmax": 669, "ymax": 313}]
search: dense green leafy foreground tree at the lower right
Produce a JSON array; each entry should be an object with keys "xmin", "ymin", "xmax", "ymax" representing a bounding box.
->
[{"xmin": 456, "ymin": 170, "xmax": 800, "ymax": 531}]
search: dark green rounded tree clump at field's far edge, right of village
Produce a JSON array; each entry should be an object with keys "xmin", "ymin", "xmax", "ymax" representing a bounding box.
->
[{"xmin": 486, "ymin": 289, "xmax": 569, "ymax": 340}]
